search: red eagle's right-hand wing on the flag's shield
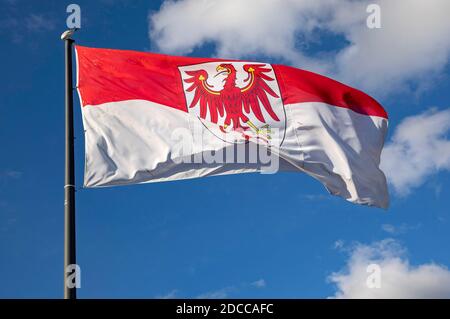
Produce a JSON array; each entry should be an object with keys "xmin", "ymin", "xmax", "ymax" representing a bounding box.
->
[{"xmin": 241, "ymin": 64, "xmax": 280, "ymax": 123}]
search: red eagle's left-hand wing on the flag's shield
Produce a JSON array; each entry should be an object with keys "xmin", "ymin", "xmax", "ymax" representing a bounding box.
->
[{"xmin": 184, "ymin": 70, "xmax": 224, "ymax": 123}]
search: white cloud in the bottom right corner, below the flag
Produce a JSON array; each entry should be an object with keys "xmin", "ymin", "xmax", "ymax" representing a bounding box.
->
[{"xmin": 328, "ymin": 239, "xmax": 450, "ymax": 299}]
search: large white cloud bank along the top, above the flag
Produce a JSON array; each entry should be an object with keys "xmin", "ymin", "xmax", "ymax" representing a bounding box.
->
[{"xmin": 149, "ymin": 0, "xmax": 450, "ymax": 93}]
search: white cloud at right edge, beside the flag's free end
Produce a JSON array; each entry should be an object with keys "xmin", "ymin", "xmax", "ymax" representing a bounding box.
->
[{"xmin": 381, "ymin": 109, "xmax": 450, "ymax": 195}]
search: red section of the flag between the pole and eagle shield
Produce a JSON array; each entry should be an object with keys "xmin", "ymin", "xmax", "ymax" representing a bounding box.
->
[{"xmin": 76, "ymin": 45, "xmax": 203, "ymax": 112}]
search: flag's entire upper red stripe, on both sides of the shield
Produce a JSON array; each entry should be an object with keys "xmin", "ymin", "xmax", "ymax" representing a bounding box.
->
[{"xmin": 76, "ymin": 45, "xmax": 387, "ymax": 118}]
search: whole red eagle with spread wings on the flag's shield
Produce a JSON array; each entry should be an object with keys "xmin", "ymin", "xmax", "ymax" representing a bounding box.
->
[{"xmin": 184, "ymin": 63, "xmax": 280, "ymax": 139}]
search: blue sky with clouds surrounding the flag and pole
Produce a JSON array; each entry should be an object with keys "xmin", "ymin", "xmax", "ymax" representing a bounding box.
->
[{"xmin": 0, "ymin": 0, "xmax": 450, "ymax": 298}]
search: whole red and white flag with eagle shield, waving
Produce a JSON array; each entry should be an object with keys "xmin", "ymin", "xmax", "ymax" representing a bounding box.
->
[{"xmin": 76, "ymin": 46, "xmax": 389, "ymax": 208}]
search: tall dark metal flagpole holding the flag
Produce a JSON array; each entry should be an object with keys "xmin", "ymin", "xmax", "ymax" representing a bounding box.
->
[{"xmin": 61, "ymin": 30, "xmax": 78, "ymax": 299}]
